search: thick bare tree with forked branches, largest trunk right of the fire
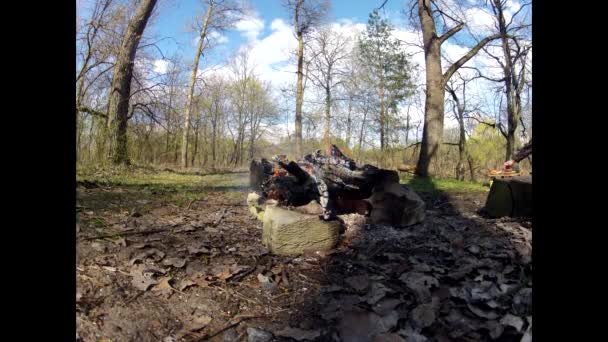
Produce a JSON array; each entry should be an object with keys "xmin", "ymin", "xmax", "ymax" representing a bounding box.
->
[{"xmin": 412, "ymin": 0, "xmax": 501, "ymax": 177}]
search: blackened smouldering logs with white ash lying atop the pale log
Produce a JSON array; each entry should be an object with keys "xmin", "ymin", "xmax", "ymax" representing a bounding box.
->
[{"xmin": 250, "ymin": 145, "xmax": 424, "ymax": 220}]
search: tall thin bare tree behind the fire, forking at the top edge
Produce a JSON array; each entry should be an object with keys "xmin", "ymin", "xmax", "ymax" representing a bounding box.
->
[{"xmin": 284, "ymin": 0, "xmax": 329, "ymax": 158}]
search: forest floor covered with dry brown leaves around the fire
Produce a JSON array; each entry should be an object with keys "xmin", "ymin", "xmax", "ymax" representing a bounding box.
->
[{"xmin": 76, "ymin": 170, "xmax": 532, "ymax": 342}]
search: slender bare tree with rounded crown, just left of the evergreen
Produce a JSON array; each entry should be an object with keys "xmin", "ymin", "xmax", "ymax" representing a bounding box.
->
[{"xmin": 307, "ymin": 27, "xmax": 350, "ymax": 154}]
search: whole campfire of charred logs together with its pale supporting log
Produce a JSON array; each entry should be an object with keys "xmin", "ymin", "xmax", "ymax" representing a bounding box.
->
[{"xmin": 247, "ymin": 145, "xmax": 425, "ymax": 254}]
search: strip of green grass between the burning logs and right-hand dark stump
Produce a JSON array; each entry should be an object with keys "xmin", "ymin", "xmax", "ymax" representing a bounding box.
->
[{"xmin": 400, "ymin": 174, "xmax": 489, "ymax": 194}]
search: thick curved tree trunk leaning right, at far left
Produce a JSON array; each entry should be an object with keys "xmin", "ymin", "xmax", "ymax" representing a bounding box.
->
[{"xmin": 108, "ymin": 0, "xmax": 156, "ymax": 164}]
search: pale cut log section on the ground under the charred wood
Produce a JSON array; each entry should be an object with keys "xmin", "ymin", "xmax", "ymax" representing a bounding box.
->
[{"xmin": 262, "ymin": 205, "xmax": 341, "ymax": 255}]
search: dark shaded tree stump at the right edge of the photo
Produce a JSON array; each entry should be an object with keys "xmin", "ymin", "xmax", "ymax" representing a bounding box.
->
[{"xmin": 485, "ymin": 176, "xmax": 532, "ymax": 218}]
